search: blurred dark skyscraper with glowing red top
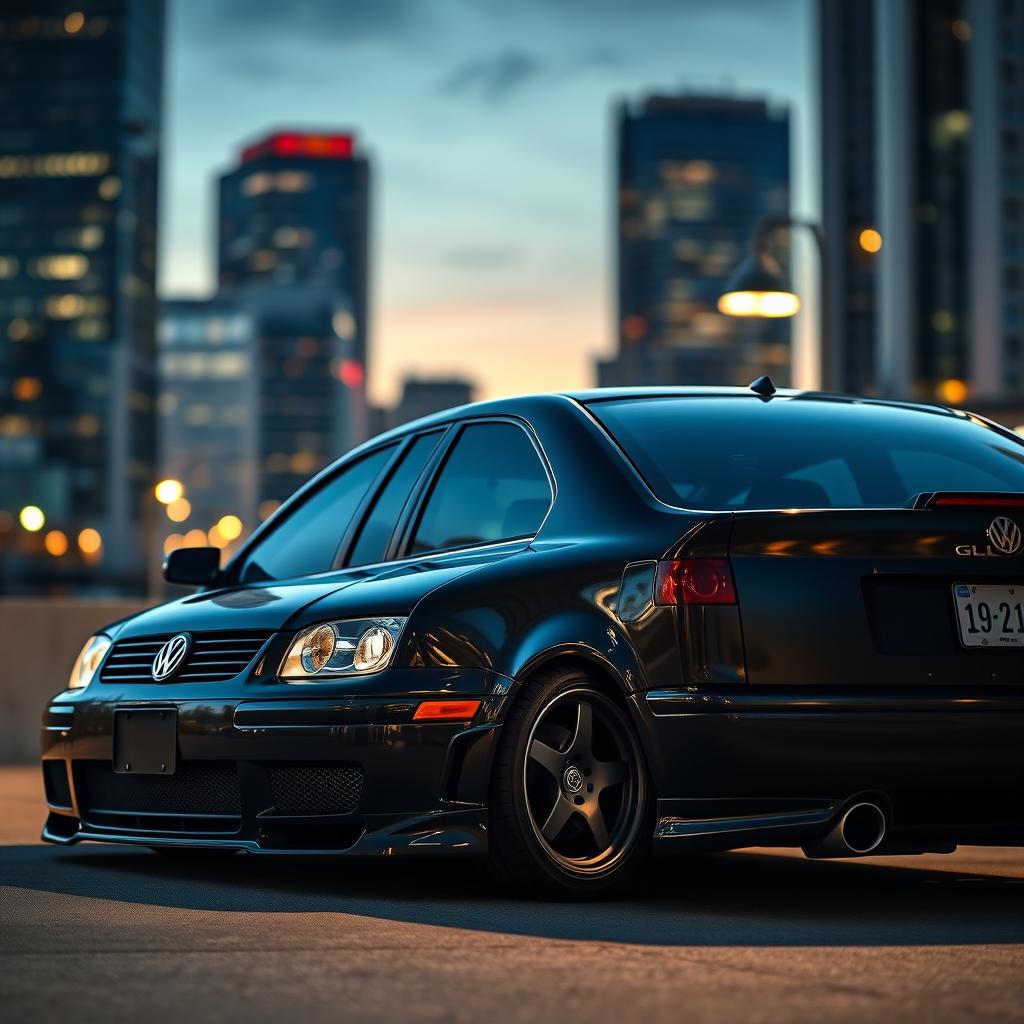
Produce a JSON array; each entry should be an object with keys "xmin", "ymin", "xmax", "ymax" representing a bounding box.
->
[{"xmin": 218, "ymin": 131, "xmax": 370, "ymax": 501}]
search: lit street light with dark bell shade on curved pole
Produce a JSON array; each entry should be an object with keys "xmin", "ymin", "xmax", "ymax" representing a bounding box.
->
[{"xmin": 718, "ymin": 215, "xmax": 834, "ymax": 389}]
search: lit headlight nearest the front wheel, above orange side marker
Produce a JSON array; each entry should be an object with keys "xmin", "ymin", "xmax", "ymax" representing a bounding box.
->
[{"xmin": 281, "ymin": 618, "xmax": 407, "ymax": 681}]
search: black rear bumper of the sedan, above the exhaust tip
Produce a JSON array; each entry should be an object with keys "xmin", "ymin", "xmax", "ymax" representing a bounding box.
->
[{"xmin": 637, "ymin": 685, "xmax": 1024, "ymax": 853}]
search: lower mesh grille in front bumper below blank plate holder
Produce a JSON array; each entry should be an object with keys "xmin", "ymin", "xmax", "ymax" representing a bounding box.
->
[{"xmin": 75, "ymin": 761, "xmax": 242, "ymax": 818}]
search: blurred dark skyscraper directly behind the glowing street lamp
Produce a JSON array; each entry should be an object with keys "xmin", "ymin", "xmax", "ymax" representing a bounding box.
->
[{"xmin": 599, "ymin": 95, "xmax": 791, "ymax": 384}]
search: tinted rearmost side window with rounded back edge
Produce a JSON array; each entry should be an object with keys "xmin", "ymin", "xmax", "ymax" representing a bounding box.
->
[{"xmin": 413, "ymin": 423, "xmax": 551, "ymax": 552}]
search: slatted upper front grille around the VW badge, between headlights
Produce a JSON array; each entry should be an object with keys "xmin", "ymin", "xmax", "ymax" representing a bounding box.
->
[{"xmin": 99, "ymin": 630, "xmax": 270, "ymax": 683}]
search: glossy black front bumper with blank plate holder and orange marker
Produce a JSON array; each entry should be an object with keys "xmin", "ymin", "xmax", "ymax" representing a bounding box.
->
[{"xmin": 42, "ymin": 670, "xmax": 508, "ymax": 855}]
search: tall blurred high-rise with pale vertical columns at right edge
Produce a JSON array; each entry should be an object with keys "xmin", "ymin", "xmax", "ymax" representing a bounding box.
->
[{"xmin": 819, "ymin": 0, "xmax": 1024, "ymax": 404}]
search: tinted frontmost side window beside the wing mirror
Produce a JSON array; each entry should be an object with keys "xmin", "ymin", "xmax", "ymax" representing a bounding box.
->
[{"xmin": 240, "ymin": 444, "xmax": 394, "ymax": 583}]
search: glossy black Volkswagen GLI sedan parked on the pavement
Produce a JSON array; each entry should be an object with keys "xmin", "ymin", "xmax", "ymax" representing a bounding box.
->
[{"xmin": 43, "ymin": 380, "xmax": 1024, "ymax": 892}]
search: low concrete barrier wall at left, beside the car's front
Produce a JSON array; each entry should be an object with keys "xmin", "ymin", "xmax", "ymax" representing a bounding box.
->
[{"xmin": 0, "ymin": 598, "xmax": 145, "ymax": 764}]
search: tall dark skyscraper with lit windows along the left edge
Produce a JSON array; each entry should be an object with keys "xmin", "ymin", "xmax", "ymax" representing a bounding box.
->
[{"xmin": 0, "ymin": 0, "xmax": 164, "ymax": 592}]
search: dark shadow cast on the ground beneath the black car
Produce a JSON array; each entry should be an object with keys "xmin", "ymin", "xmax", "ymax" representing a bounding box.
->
[{"xmin": 0, "ymin": 846, "xmax": 1024, "ymax": 946}]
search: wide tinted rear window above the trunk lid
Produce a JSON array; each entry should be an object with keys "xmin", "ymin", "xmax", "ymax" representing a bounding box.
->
[{"xmin": 590, "ymin": 395, "xmax": 1024, "ymax": 510}]
